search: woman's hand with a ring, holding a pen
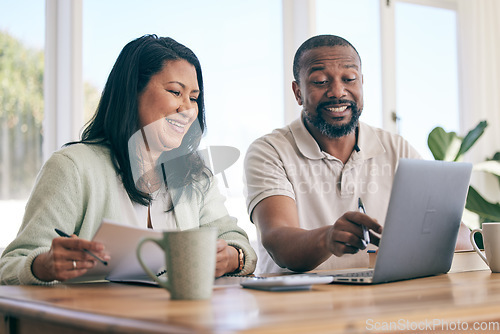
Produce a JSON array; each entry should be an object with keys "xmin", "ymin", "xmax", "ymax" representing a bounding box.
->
[{"xmin": 31, "ymin": 234, "xmax": 110, "ymax": 282}]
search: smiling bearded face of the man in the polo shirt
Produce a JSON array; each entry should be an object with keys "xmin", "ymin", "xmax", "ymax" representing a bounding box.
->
[{"xmin": 293, "ymin": 46, "xmax": 363, "ymax": 138}]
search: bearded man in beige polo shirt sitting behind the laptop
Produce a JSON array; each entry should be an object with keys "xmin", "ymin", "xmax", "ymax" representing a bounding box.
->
[{"xmin": 245, "ymin": 35, "xmax": 466, "ymax": 272}]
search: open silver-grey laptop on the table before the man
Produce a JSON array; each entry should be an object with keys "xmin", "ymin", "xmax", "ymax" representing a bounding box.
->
[{"xmin": 318, "ymin": 159, "xmax": 472, "ymax": 284}]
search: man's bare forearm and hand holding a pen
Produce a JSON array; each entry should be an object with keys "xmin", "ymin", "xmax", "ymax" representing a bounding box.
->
[{"xmin": 252, "ymin": 196, "xmax": 382, "ymax": 272}]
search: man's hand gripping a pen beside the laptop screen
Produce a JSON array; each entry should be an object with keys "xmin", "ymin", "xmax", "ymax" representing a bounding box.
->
[{"xmin": 325, "ymin": 211, "xmax": 382, "ymax": 256}]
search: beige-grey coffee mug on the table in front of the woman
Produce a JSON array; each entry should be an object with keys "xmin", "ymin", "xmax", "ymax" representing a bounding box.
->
[{"xmin": 137, "ymin": 228, "xmax": 217, "ymax": 299}]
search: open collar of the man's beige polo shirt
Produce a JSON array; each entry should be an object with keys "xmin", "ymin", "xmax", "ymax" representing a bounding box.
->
[{"xmin": 290, "ymin": 117, "xmax": 385, "ymax": 160}]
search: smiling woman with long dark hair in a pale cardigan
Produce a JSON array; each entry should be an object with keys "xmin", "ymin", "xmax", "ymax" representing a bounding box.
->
[{"xmin": 0, "ymin": 35, "xmax": 257, "ymax": 284}]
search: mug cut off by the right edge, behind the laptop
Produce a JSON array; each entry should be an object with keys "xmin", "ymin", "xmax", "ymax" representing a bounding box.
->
[{"xmin": 470, "ymin": 223, "xmax": 500, "ymax": 273}]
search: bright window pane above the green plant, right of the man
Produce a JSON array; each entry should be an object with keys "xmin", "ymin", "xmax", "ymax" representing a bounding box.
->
[{"xmin": 395, "ymin": 2, "xmax": 460, "ymax": 159}]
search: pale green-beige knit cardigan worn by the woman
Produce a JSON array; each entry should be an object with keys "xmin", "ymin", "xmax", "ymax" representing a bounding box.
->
[{"xmin": 0, "ymin": 144, "xmax": 257, "ymax": 284}]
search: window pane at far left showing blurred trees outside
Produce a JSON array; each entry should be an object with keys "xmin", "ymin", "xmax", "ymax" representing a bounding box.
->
[{"xmin": 0, "ymin": 0, "xmax": 45, "ymax": 247}]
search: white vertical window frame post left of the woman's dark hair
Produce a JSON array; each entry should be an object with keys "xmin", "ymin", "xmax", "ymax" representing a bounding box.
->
[{"xmin": 42, "ymin": 0, "xmax": 83, "ymax": 161}]
